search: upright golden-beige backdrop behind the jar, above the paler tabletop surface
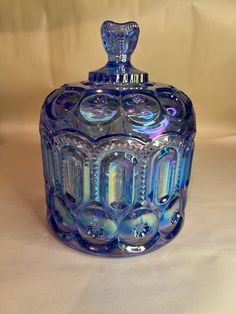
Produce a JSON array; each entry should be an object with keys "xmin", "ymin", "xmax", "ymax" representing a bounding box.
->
[{"xmin": 0, "ymin": 0, "xmax": 236, "ymax": 134}]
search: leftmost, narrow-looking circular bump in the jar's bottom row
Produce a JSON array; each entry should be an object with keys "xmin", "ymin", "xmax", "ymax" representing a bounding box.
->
[{"xmin": 51, "ymin": 196, "xmax": 76, "ymax": 240}]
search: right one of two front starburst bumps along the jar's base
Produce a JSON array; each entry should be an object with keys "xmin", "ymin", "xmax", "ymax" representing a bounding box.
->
[{"xmin": 119, "ymin": 208, "xmax": 159, "ymax": 253}]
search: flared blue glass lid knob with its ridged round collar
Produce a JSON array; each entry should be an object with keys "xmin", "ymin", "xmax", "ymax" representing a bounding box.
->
[{"xmin": 89, "ymin": 21, "xmax": 148, "ymax": 85}]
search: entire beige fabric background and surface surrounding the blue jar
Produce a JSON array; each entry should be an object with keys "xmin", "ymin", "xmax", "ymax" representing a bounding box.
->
[{"xmin": 0, "ymin": 0, "xmax": 236, "ymax": 314}]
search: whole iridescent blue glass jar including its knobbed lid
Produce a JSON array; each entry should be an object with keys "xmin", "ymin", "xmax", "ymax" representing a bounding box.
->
[{"xmin": 40, "ymin": 21, "xmax": 196, "ymax": 256}]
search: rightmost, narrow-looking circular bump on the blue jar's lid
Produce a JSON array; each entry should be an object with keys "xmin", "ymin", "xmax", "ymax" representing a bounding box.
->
[{"xmin": 157, "ymin": 92, "xmax": 185, "ymax": 119}]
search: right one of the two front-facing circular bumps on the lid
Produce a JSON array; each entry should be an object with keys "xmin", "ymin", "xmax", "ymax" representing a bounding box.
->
[{"xmin": 122, "ymin": 94, "xmax": 160, "ymax": 125}]
